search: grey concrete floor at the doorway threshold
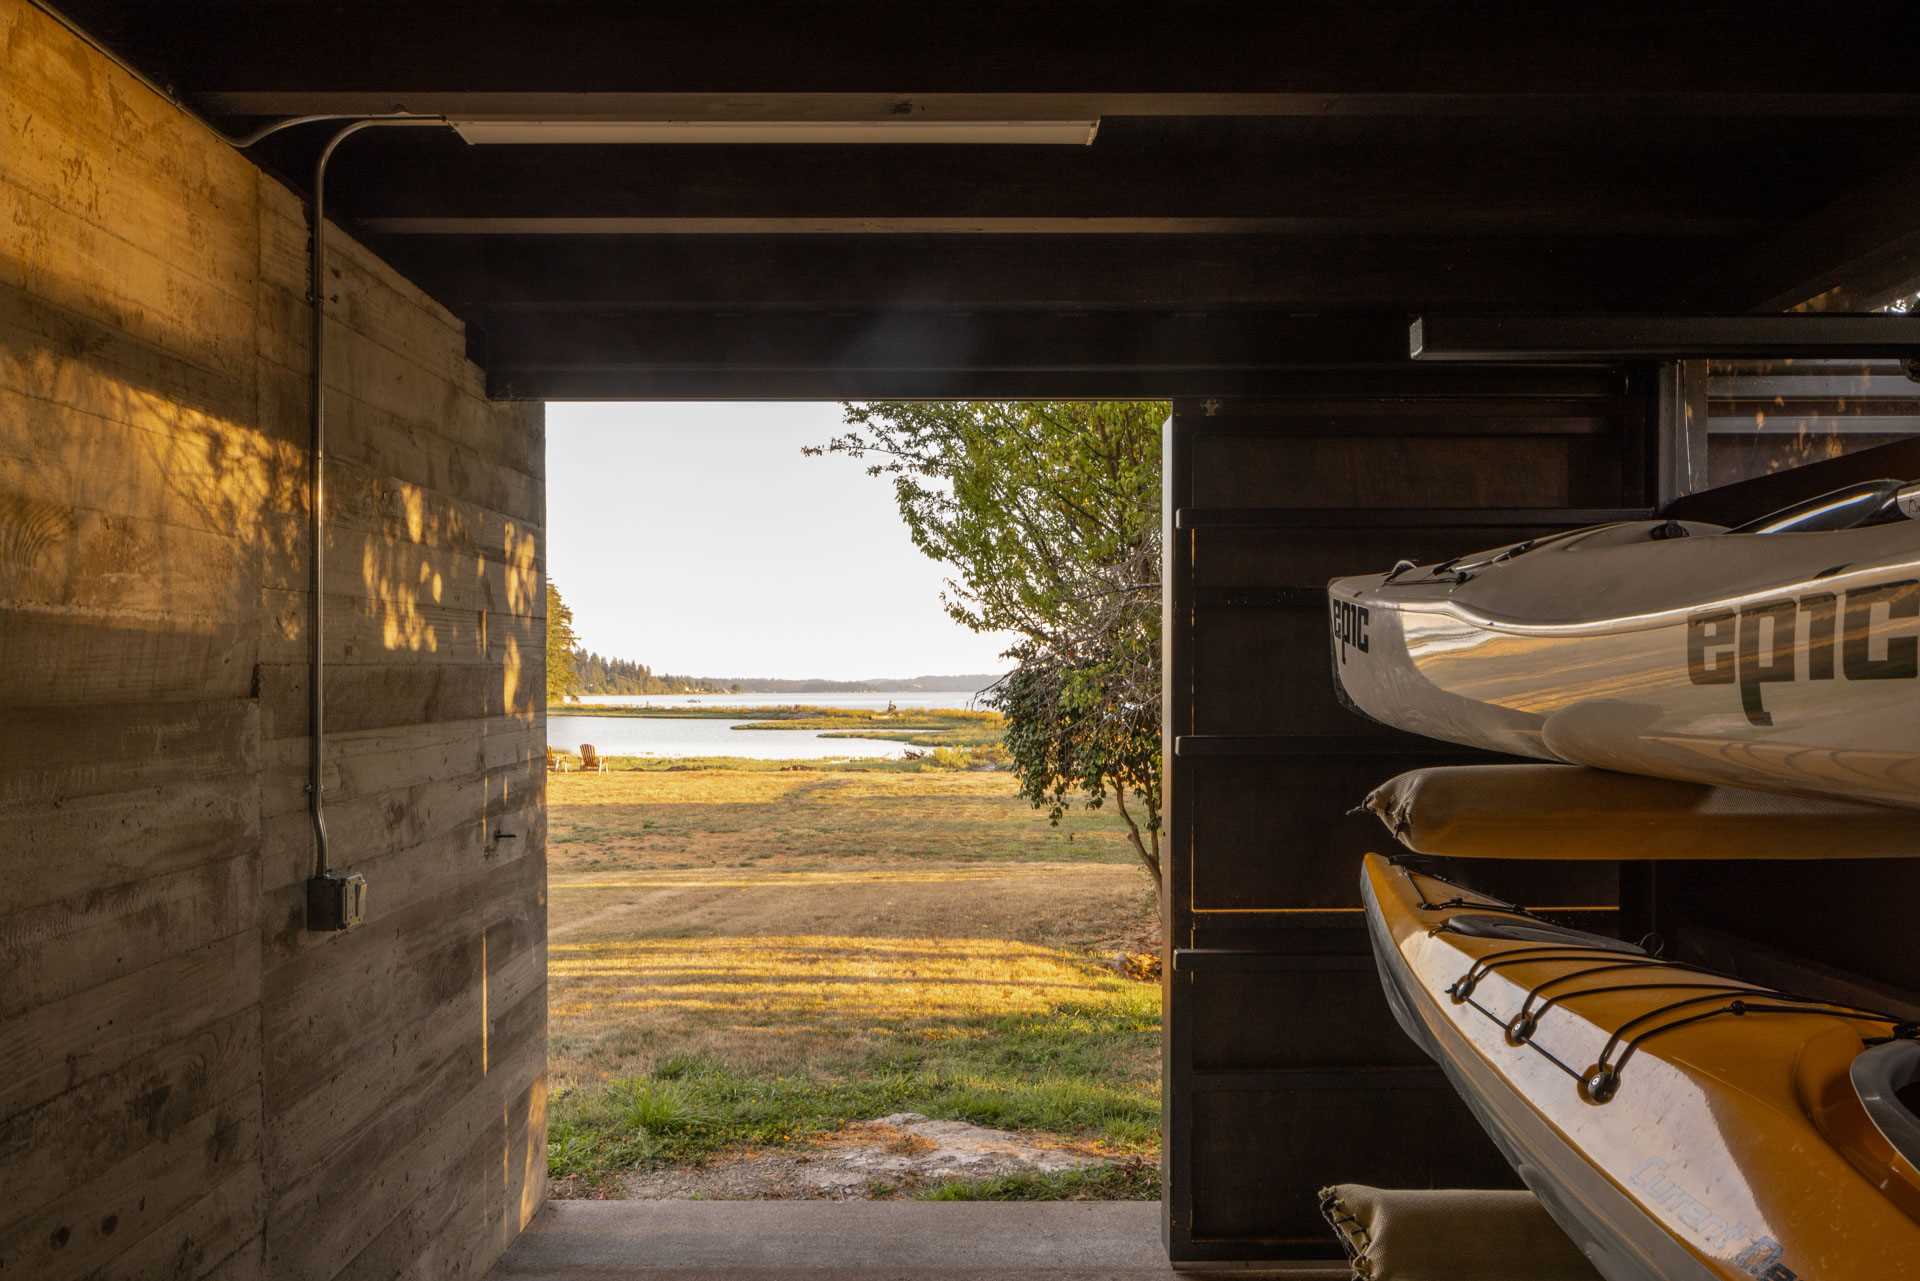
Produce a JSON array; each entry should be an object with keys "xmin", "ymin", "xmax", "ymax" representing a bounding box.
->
[{"xmin": 492, "ymin": 1200, "xmax": 1348, "ymax": 1281}]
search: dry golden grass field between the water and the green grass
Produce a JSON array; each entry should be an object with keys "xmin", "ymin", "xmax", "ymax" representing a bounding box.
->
[{"xmin": 549, "ymin": 770, "xmax": 1150, "ymax": 1085}]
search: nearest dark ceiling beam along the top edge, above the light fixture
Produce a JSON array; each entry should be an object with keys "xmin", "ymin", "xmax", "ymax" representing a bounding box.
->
[{"xmin": 63, "ymin": 0, "xmax": 1920, "ymax": 99}]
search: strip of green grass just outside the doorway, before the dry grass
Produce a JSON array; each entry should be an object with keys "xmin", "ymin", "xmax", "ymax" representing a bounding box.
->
[{"xmin": 549, "ymin": 983, "xmax": 1160, "ymax": 1198}]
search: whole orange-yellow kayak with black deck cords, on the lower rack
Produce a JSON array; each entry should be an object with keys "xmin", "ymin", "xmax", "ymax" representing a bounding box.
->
[{"xmin": 1361, "ymin": 855, "xmax": 1920, "ymax": 1281}]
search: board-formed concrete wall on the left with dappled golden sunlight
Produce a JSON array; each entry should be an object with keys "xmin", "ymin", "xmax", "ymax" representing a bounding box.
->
[{"xmin": 0, "ymin": 0, "xmax": 545, "ymax": 1281}]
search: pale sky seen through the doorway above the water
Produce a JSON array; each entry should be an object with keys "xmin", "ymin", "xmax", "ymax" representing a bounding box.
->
[{"xmin": 547, "ymin": 401, "xmax": 1010, "ymax": 680}]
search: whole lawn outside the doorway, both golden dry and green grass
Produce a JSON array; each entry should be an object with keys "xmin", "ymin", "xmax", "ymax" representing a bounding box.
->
[{"xmin": 549, "ymin": 762, "xmax": 1160, "ymax": 1198}]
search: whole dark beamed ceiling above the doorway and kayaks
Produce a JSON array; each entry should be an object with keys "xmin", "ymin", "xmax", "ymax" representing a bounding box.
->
[{"xmin": 48, "ymin": 0, "xmax": 1920, "ymax": 398}]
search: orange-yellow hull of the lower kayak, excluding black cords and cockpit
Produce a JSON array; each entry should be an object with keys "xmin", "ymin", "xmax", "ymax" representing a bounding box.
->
[{"xmin": 1361, "ymin": 857, "xmax": 1920, "ymax": 1281}]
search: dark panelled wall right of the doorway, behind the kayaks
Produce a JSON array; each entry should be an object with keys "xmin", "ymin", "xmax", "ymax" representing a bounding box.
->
[{"xmin": 1165, "ymin": 367, "xmax": 1655, "ymax": 1262}]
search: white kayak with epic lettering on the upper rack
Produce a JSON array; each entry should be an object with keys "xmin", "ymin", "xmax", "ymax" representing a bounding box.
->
[{"xmin": 1329, "ymin": 480, "xmax": 1920, "ymax": 809}]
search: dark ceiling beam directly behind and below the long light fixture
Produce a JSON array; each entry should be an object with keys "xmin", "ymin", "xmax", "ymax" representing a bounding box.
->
[{"xmin": 322, "ymin": 119, "xmax": 1804, "ymax": 242}]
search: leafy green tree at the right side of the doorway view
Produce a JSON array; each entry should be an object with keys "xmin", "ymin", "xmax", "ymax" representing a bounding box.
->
[{"xmin": 804, "ymin": 401, "xmax": 1167, "ymax": 891}]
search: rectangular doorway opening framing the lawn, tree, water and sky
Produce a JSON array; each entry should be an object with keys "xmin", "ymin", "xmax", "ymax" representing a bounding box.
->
[{"xmin": 547, "ymin": 401, "xmax": 1167, "ymax": 1200}]
